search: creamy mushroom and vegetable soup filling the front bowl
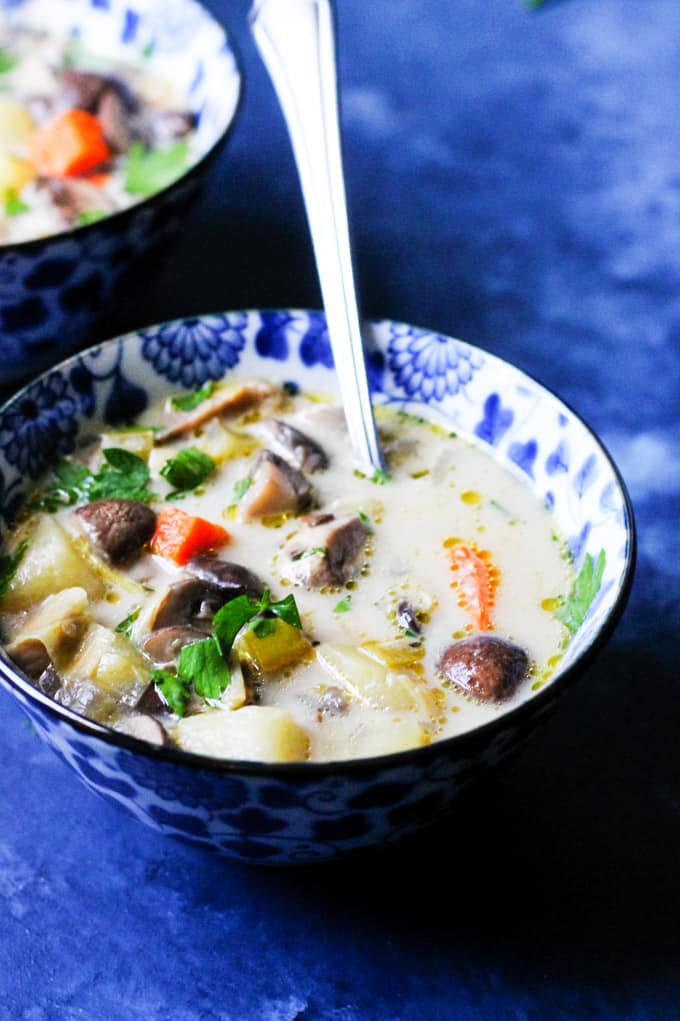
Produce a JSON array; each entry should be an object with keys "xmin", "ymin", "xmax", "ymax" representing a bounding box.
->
[{"xmin": 0, "ymin": 380, "xmax": 592, "ymax": 761}]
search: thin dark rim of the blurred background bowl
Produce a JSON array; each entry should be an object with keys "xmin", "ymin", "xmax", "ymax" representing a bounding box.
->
[{"xmin": 0, "ymin": 0, "xmax": 244, "ymax": 254}]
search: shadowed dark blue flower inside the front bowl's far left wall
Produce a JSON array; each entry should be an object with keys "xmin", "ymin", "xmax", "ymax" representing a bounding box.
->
[{"xmin": 0, "ymin": 372, "xmax": 79, "ymax": 479}]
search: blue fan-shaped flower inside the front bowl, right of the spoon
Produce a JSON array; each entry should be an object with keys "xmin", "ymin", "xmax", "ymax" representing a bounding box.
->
[{"xmin": 387, "ymin": 324, "xmax": 484, "ymax": 400}]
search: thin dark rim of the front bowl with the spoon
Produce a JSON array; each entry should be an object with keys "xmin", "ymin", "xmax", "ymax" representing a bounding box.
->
[{"xmin": 0, "ymin": 308, "xmax": 637, "ymax": 780}]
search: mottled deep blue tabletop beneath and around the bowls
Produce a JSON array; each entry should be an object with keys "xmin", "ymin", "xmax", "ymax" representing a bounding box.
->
[{"xmin": 0, "ymin": 0, "xmax": 680, "ymax": 1021}]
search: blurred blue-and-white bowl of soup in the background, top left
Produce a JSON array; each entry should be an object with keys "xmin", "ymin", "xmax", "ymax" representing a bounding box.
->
[{"xmin": 0, "ymin": 0, "xmax": 240, "ymax": 386}]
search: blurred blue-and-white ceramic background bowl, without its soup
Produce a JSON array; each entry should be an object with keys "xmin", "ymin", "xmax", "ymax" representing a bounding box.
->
[{"xmin": 0, "ymin": 0, "xmax": 240, "ymax": 388}]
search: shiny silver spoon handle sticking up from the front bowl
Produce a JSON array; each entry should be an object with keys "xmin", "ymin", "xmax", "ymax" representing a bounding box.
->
[{"xmin": 249, "ymin": 0, "xmax": 384, "ymax": 474}]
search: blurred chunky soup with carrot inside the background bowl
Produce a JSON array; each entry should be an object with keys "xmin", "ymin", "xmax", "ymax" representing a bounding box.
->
[{"xmin": 0, "ymin": 22, "xmax": 194, "ymax": 244}]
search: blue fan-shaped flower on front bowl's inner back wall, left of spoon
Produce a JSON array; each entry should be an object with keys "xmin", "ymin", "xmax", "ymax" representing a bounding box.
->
[{"xmin": 141, "ymin": 312, "xmax": 247, "ymax": 389}]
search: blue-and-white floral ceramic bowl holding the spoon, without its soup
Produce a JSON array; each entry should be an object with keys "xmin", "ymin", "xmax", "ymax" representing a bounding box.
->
[{"xmin": 0, "ymin": 311, "xmax": 634, "ymax": 864}]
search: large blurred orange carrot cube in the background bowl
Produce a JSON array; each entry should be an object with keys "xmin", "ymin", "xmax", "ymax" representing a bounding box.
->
[{"xmin": 31, "ymin": 109, "xmax": 111, "ymax": 178}]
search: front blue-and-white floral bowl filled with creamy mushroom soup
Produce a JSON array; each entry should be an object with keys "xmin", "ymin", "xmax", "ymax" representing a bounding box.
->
[{"xmin": 0, "ymin": 309, "xmax": 634, "ymax": 864}]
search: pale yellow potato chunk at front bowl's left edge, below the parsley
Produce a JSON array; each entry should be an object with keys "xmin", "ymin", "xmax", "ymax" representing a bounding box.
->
[{"xmin": 2, "ymin": 515, "xmax": 104, "ymax": 613}]
